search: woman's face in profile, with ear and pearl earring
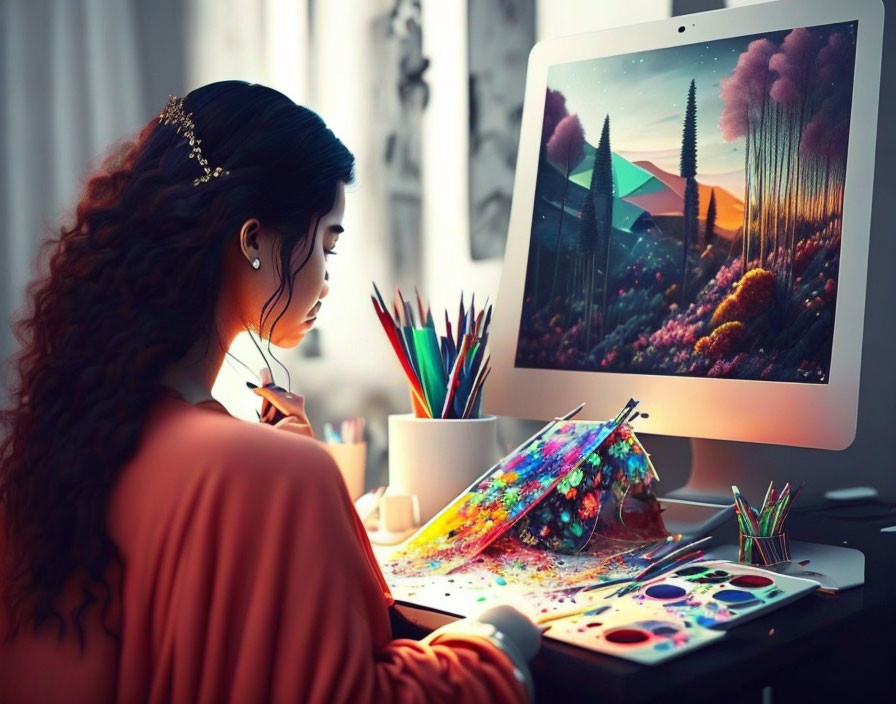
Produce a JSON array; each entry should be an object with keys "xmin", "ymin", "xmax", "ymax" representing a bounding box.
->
[{"xmin": 234, "ymin": 182, "xmax": 345, "ymax": 347}]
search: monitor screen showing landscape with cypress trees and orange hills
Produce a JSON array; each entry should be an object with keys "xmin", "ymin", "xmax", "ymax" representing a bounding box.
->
[{"xmin": 514, "ymin": 21, "xmax": 867, "ymax": 384}]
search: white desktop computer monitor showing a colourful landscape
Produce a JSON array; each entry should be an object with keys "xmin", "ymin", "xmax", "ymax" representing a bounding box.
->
[{"xmin": 484, "ymin": 0, "xmax": 883, "ymax": 506}]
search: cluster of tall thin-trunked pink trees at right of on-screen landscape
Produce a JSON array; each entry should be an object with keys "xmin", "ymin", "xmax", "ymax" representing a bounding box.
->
[{"xmin": 719, "ymin": 28, "xmax": 855, "ymax": 291}]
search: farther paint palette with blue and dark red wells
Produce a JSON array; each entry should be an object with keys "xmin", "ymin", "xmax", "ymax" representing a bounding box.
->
[{"xmin": 614, "ymin": 560, "xmax": 818, "ymax": 628}]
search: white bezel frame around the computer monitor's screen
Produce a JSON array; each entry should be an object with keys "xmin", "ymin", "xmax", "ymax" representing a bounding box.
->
[{"xmin": 483, "ymin": 0, "xmax": 883, "ymax": 450}]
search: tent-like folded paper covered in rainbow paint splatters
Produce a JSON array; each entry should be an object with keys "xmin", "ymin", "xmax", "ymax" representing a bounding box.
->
[{"xmin": 386, "ymin": 400, "xmax": 667, "ymax": 576}]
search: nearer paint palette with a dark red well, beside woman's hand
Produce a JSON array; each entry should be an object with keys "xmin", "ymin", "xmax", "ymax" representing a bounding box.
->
[{"xmin": 544, "ymin": 603, "xmax": 725, "ymax": 665}]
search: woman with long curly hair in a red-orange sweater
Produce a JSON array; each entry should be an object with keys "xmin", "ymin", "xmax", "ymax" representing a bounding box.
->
[{"xmin": 0, "ymin": 81, "xmax": 538, "ymax": 704}]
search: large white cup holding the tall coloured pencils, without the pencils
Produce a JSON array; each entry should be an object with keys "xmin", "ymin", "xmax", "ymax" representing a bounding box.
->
[{"xmin": 389, "ymin": 413, "xmax": 498, "ymax": 523}]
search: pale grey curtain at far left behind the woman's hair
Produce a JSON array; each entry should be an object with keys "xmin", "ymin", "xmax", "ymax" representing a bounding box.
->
[{"xmin": 0, "ymin": 0, "xmax": 157, "ymax": 401}]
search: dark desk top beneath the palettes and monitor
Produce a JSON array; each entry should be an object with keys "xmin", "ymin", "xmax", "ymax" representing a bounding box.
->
[{"xmin": 378, "ymin": 503, "xmax": 896, "ymax": 704}]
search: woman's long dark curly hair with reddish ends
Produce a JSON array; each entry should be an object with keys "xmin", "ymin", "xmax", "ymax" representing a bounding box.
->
[{"xmin": 0, "ymin": 81, "xmax": 354, "ymax": 651}]
